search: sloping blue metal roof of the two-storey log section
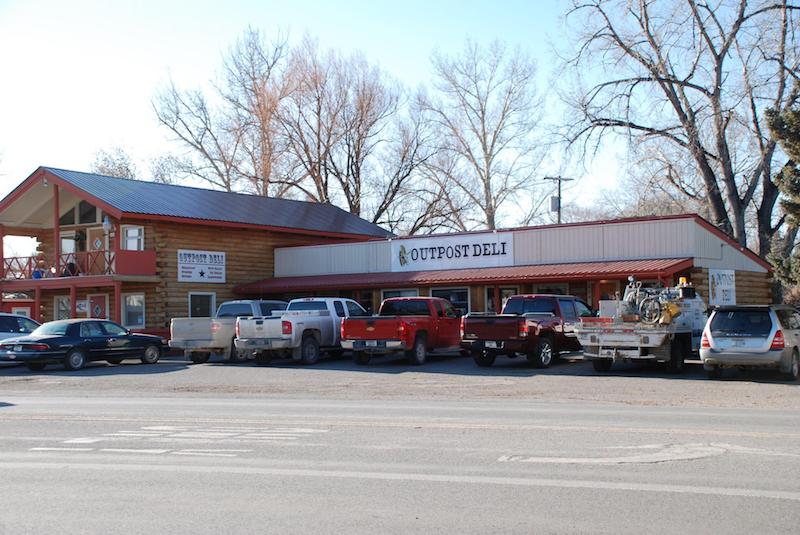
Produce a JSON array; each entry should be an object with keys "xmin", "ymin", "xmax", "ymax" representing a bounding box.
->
[{"xmin": 41, "ymin": 167, "xmax": 391, "ymax": 237}]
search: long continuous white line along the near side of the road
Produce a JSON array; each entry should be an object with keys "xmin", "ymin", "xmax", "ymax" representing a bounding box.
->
[{"xmin": 6, "ymin": 461, "xmax": 800, "ymax": 502}]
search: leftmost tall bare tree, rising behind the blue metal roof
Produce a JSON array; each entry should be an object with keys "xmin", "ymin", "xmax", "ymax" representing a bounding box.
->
[{"xmin": 153, "ymin": 29, "xmax": 291, "ymax": 196}]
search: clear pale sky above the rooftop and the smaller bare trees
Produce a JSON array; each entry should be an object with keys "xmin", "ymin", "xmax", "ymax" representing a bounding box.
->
[{"xmin": 0, "ymin": 0, "xmax": 614, "ymax": 205}]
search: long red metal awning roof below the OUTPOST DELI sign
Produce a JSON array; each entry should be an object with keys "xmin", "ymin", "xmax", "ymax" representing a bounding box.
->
[{"xmin": 234, "ymin": 258, "xmax": 693, "ymax": 295}]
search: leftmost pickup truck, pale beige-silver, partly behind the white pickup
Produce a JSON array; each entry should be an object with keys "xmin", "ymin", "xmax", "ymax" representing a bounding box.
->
[{"xmin": 169, "ymin": 300, "xmax": 287, "ymax": 364}]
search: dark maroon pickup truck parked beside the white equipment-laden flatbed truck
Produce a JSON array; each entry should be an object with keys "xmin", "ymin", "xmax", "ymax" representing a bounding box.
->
[{"xmin": 461, "ymin": 294, "xmax": 592, "ymax": 368}]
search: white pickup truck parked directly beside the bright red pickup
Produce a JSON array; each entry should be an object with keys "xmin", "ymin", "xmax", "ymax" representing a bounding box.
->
[{"xmin": 234, "ymin": 297, "xmax": 369, "ymax": 364}]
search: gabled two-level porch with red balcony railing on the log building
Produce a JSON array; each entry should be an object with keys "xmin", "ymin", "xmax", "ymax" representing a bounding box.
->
[{"xmin": 0, "ymin": 169, "xmax": 158, "ymax": 320}]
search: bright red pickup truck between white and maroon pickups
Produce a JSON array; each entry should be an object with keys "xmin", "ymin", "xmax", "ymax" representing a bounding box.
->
[{"xmin": 341, "ymin": 297, "xmax": 461, "ymax": 364}]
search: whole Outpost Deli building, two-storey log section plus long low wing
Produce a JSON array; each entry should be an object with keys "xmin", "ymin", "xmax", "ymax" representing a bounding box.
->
[{"xmin": 0, "ymin": 167, "xmax": 772, "ymax": 334}]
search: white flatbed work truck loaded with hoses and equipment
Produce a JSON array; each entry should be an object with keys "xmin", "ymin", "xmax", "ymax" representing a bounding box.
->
[{"xmin": 575, "ymin": 277, "xmax": 707, "ymax": 372}]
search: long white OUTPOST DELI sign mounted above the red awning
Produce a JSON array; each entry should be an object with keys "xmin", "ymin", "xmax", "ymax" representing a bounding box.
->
[{"xmin": 392, "ymin": 232, "xmax": 514, "ymax": 271}]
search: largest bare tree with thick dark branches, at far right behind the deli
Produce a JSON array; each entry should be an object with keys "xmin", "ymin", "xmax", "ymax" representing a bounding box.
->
[{"xmin": 567, "ymin": 0, "xmax": 800, "ymax": 255}]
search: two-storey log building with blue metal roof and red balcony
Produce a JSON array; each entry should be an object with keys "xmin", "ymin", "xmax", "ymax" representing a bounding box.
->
[{"xmin": 0, "ymin": 167, "xmax": 390, "ymax": 334}]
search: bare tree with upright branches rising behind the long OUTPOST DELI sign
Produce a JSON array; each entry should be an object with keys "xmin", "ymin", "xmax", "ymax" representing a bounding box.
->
[{"xmin": 423, "ymin": 42, "xmax": 539, "ymax": 229}]
